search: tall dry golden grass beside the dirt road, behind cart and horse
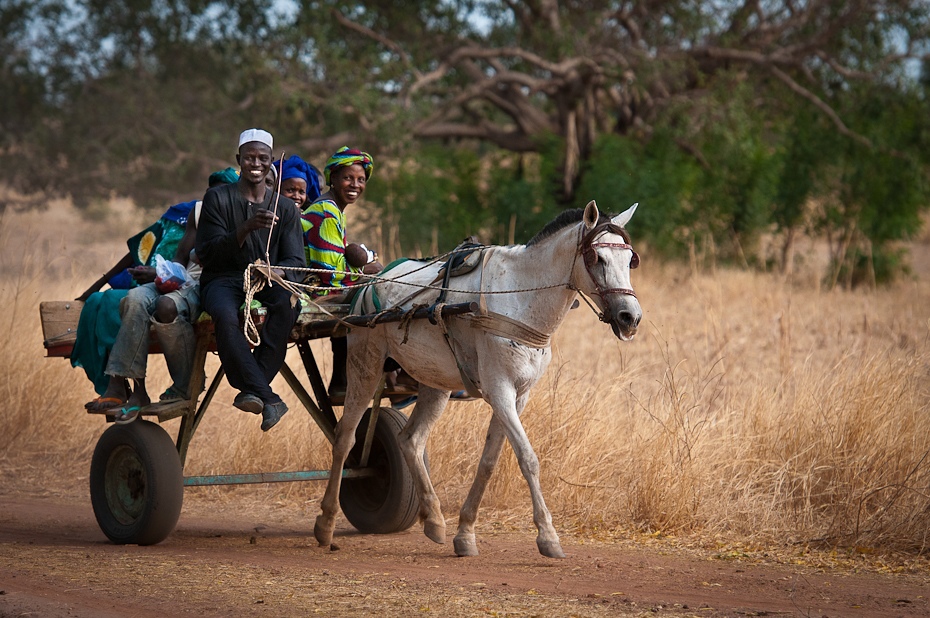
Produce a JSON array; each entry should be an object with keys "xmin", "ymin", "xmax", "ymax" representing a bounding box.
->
[{"xmin": 0, "ymin": 197, "xmax": 930, "ymax": 553}]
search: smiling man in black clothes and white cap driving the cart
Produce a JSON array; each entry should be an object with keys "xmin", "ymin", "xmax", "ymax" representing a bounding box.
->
[{"xmin": 197, "ymin": 129, "xmax": 306, "ymax": 431}]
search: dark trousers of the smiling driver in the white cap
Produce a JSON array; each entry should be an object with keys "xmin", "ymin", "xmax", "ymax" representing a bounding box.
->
[{"xmin": 200, "ymin": 277, "xmax": 300, "ymax": 403}]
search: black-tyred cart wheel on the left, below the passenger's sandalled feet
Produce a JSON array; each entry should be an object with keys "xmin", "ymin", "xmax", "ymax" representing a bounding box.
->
[{"xmin": 90, "ymin": 419, "xmax": 184, "ymax": 545}]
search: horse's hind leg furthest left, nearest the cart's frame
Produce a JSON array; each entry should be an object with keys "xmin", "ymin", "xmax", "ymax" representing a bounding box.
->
[{"xmin": 313, "ymin": 340, "xmax": 384, "ymax": 547}]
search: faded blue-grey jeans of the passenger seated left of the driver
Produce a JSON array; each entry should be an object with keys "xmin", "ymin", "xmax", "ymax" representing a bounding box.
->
[{"xmin": 106, "ymin": 283, "xmax": 200, "ymax": 395}]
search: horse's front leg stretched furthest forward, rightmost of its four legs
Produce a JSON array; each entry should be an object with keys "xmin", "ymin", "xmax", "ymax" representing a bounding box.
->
[{"xmin": 485, "ymin": 383, "xmax": 565, "ymax": 558}]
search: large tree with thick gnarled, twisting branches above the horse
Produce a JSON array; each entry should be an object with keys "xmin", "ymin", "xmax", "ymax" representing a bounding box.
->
[{"xmin": 318, "ymin": 0, "xmax": 930, "ymax": 197}]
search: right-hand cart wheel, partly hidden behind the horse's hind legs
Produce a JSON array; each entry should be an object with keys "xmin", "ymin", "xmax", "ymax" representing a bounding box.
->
[{"xmin": 339, "ymin": 408, "xmax": 420, "ymax": 534}]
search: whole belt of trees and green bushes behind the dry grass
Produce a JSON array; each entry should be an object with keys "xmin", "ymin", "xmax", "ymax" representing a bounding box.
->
[{"xmin": 0, "ymin": 0, "xmax": 930, "ymax": 285}]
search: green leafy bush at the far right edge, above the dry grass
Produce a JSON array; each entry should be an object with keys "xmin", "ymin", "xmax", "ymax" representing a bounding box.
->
[{"xmin": 811, "ymin": 82, "xmax": 930, "ymax": 286}]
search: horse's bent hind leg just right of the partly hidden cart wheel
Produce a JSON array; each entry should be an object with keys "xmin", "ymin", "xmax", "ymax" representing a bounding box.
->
[{"xmin": 398, "ymin": 385, "xmax": 449, "ymax": 543}]
